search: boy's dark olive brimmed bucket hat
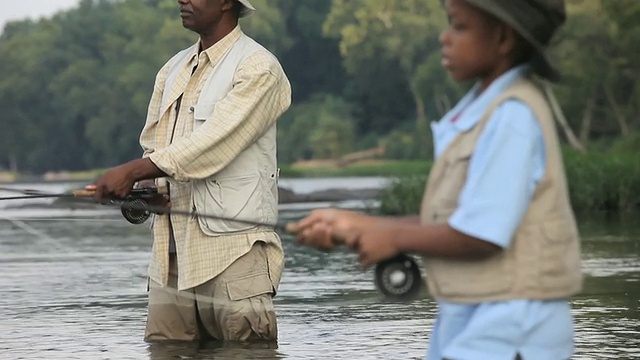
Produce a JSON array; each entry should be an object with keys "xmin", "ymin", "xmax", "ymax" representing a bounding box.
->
[{"xmin": 465, "ymin": 0, "xmax": 567, "ymax": 80}]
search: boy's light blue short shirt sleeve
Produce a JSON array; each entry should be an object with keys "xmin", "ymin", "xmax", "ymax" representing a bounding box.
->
[{"xmin": 449, "ymin": 100, "xmax": 546, "ymax": 248}]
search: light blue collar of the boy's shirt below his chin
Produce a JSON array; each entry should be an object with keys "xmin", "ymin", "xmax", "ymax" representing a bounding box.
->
[{"xmin": 440, "ymin": 64, "xmax": 531, "ymax": 132}]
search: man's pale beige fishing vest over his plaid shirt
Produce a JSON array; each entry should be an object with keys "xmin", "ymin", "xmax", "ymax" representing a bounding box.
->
[{"xmin": 163, "ymin": 34, "xmax": 279, "ymax": 236}]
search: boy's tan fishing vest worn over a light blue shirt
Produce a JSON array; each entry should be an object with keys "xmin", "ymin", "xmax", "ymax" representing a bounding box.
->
[{"xmin": 420, "ymin": 79, "xmax": 582, "ymax": 303}]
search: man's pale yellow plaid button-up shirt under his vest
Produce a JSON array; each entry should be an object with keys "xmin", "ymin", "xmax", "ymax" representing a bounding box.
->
[{"xmin": 140, "ymin": 26, "xmax": 291, "ymax": 290}]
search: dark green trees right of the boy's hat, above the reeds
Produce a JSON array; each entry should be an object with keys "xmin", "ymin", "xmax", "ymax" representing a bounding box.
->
[{"xmin": 553, "ymin": 0, "xmax": 640, "ymax": 143}]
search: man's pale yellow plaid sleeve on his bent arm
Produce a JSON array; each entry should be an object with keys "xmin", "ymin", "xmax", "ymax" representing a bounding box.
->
[{"xmin": 149, "ymin": 52, "xmax": 291, "ymax": 181}]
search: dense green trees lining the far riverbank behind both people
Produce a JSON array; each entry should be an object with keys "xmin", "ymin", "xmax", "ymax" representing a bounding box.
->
[{"xmin": 0, "ymin": 0, "xmax": 640, "ymax": 173}]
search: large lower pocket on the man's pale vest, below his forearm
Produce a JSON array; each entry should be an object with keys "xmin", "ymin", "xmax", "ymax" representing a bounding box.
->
[{"xmin": 193, "ymin": 174, "xmax": 264, "ymax": 236}]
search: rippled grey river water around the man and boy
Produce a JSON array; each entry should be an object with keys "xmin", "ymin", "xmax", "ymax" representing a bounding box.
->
[{"xmin": 0, "ymin": 179, "xmax": 640, "ymax": 360}]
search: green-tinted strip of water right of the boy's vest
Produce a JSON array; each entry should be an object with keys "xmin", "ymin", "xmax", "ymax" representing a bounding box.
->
[{"xmin": 573, "ymin": 218, "xmax": 640, "ymax": 359}]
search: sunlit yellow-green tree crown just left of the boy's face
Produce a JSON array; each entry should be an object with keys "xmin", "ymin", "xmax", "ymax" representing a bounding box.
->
[{"xmin": 325, "ymin": 0, "xmax": 444, "ymax": 128}]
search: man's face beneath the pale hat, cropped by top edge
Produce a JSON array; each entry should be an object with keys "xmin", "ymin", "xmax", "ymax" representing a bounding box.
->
[{"xmin": 178, "ymin": 0, "xmax": 226, "ymax": 34}]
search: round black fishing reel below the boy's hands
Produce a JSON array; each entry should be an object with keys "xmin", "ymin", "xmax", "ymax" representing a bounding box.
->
[{"xmin": 375, "ymin": 254, "xmax": 422, "ymax": 302}]
